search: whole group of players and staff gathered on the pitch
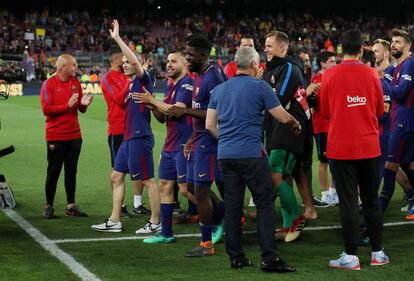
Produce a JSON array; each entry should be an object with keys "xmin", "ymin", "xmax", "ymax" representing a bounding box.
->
[{"xmin": 41, "ymin": 20, "xmax": 414, "ymax": 272}]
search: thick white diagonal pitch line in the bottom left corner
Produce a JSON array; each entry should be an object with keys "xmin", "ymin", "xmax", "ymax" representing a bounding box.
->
[{"xmin": 2, "ymin": 209, "xmax": 101, "ymax": 281}]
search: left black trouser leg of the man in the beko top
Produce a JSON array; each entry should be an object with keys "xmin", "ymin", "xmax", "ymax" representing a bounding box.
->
[{"xmin": 331, "ymin": 160, "xmax": 360, "ymax": 255}]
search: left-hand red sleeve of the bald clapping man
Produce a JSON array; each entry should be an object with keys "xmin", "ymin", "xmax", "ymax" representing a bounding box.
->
[{"xmin": 40, "ymin": 79, "xmax": 70, "ymax": 116}]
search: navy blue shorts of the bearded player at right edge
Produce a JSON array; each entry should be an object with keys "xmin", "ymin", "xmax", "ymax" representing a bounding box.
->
[{"xmin": 387, "ymin": 131, "xmax": 414, "ymax": 164}]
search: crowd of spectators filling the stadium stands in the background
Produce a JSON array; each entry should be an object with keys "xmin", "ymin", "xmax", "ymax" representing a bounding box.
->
[{"xmin": 0, "ymin": 9, "xmax": 414, "ymax": 80}]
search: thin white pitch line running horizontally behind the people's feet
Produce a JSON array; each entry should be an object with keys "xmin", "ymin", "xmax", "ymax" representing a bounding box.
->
[{"xmin": 52, "ymin": 221, "xmax": 414, "ymax": 244}]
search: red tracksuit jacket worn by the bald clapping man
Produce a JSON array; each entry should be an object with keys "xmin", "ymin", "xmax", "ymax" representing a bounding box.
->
[{"xmin": 40, "ymin": 75, "xmax": 87, "ymax": 141}]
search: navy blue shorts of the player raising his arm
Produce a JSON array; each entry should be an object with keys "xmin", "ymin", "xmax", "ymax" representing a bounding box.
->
[{"xmin": 114, "ymin": 136, "xmax": 154, "ymax": 180}]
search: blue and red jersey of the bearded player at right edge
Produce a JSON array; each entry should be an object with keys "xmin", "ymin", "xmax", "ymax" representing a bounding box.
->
[{"xmin": 390, "ymin": 58, "xmax": 414, "ymax": 132}]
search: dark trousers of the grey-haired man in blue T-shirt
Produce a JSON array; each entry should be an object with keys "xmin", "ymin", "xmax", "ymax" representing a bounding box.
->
[{"xmin": 219, "ymin": 158, "xmax": 276, "ymax": 260}]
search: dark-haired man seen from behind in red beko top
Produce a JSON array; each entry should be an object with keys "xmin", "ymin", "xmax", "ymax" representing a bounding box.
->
[{"xmin": 320, "ymin": 30, "xmax": 389, "ymax": 270}]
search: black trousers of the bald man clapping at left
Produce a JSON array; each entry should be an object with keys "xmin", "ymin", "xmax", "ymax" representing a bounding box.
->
[{"xmin": 45, "ymin": 139, "xmax": 82, "ymax": 205}]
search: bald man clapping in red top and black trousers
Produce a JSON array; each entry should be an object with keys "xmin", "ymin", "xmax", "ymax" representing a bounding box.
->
[{"xmin": 40, "ymin": 54, "xmax": 92, "ymax": 219}]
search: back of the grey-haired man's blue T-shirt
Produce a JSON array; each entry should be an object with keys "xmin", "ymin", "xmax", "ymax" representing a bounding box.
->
[{"xmin": 213, "ymin": 75, "xmax": 270, "ymax": 159}]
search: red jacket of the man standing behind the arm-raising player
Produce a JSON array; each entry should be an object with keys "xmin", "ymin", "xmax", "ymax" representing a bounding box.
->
[{"xmin": 101, "ymin": 70, "xmax": 128, "ymax": 136}]
